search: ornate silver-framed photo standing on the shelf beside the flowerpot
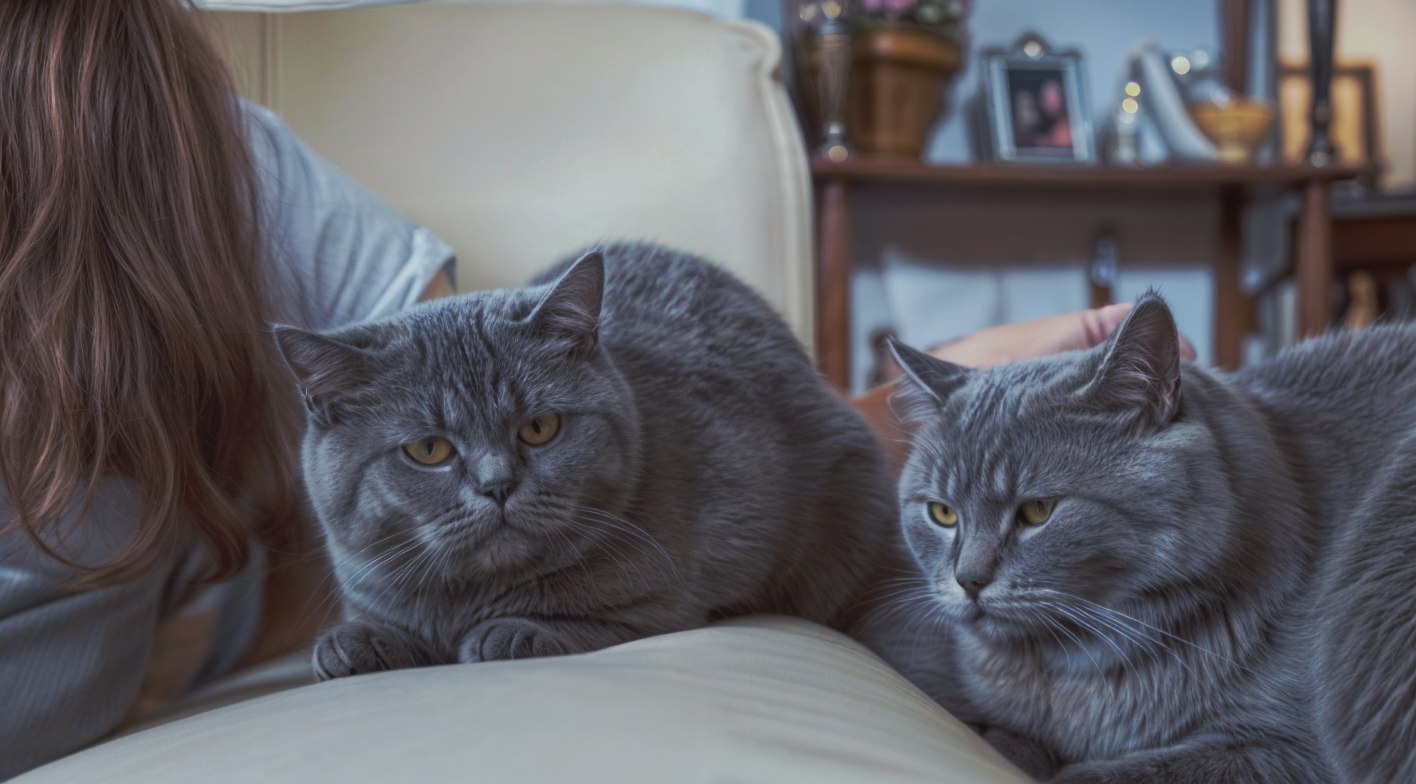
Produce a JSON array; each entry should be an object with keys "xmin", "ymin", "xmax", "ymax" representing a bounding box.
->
[{"xmin": 981, "ymin": 33, "xmax": 1096, "ymax": 163}]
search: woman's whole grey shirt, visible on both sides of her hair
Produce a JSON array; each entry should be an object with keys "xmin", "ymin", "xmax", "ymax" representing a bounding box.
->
[{"xmin": 0, "ymin": 103, "xmax": 453, "ymax": 780}]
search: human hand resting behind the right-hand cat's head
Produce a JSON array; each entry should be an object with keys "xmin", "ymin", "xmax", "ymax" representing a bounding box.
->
[{"xmin": 930, "ymin": 303, "xmax": 1195, "ymax": 368}]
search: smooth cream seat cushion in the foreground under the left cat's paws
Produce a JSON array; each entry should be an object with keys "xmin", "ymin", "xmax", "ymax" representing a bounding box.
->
[{"xmin": 16, "ymin": 617, "xmax": 1028, "ymax": 784}]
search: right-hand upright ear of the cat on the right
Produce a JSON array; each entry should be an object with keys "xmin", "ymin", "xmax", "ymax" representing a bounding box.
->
[{"xmin": 1087, "ymin": 292, "xmax": 1181, "ymax": 425}]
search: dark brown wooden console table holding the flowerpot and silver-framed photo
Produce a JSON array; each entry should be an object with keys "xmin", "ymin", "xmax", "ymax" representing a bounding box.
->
[{"xmin": 811, "ymin": 158, "xmax": 1365, "ymax": 386}]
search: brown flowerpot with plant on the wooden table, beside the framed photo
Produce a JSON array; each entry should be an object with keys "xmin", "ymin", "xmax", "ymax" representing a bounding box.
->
[{"xmin": 847, "ymin": 0, "xmax": 966, "ymax": 158}]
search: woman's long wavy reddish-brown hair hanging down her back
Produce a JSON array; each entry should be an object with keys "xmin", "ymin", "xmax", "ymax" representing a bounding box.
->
[{"xmin": 0, "ymin": 0, "xmax": 297, "ymax": 582}]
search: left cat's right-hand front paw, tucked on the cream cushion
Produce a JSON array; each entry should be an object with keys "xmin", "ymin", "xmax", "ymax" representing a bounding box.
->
[{"xmin": 457, "ymin": 617, "xmax": 654, "ymax": 662}]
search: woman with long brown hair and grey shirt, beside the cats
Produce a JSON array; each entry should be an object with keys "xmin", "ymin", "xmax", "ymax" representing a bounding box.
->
[{"xmin": 0, "ymin": 0, "xmax": 1144, "ymax": 778}]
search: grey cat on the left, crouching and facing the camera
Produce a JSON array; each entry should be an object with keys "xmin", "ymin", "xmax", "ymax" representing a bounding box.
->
[{"xmin": 276, "ymin": 245, "xmax": 898, "ymax": 679}]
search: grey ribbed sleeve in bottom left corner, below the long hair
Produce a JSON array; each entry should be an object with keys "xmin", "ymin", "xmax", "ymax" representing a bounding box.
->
[{"xmin": 0, "ymin": 480, "xmax": 169, "ymax": 780}]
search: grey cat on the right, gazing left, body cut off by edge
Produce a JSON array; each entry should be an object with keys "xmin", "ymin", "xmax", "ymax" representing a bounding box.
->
[{"xmin": 896, "ymin": 296, "xmax": 1416, "ymax": 784}]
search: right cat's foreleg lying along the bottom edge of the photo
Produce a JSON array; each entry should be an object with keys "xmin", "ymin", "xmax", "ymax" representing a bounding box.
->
[{"xmin": 1048, "ymin": 740, "xmax": 1332, "ymax": 784}]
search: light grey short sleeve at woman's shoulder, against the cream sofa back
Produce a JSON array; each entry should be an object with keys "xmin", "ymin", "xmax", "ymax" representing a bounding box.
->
[{"xmin": 244, "ymin": 102, "xmax": 456, "ymax": 330}]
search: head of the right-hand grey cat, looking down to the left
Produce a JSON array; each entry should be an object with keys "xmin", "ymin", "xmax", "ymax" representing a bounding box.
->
[{"xmin": 893, "ymin": 294, "xmax": 1232, "ymax": 640}]
